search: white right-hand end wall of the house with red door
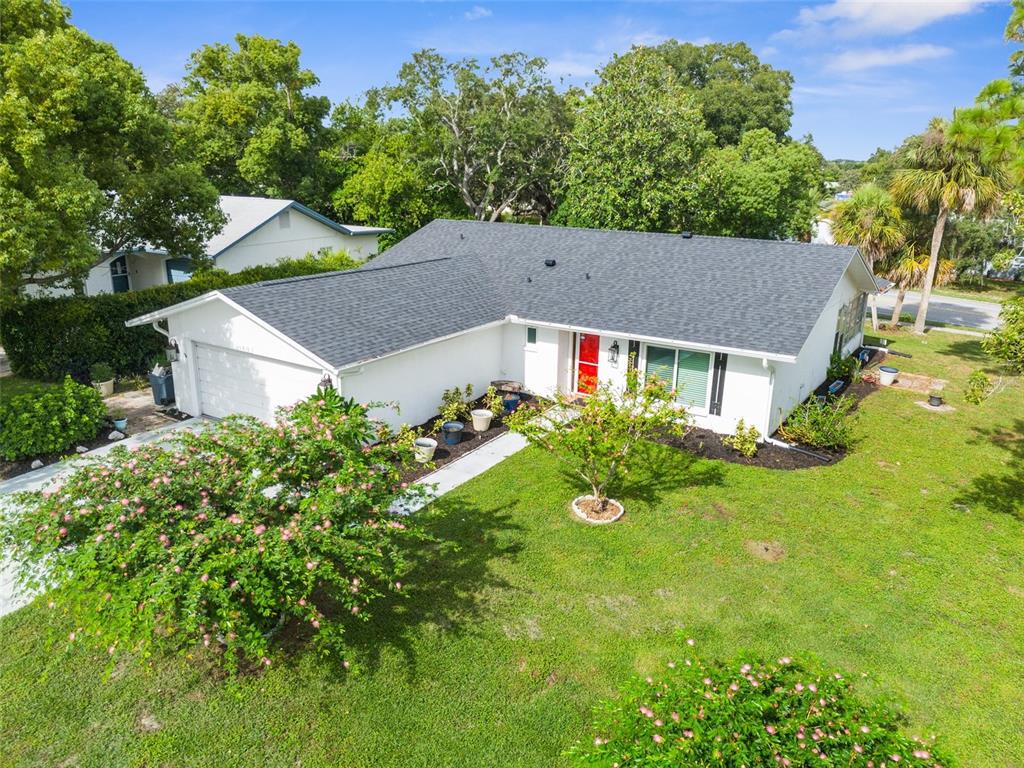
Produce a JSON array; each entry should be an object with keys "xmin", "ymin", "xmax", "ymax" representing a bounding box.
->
[{"xmin": 768, "ymin": 271, "xmax": 864, "ymax": 434}]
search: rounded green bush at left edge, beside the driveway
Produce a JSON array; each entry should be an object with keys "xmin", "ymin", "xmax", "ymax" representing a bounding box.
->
[{"xmin": 0, "ymin": 376, "xmax": 106, "ymax": 461}]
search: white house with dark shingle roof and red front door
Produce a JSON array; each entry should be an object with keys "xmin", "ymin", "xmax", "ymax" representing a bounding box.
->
[{"xmin": 128, "ymin": 220, "xmax": 876, "ymax": 434}]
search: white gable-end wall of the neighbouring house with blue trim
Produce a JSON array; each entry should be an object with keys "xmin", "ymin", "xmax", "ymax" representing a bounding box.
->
[{"xmin": 217, "ymin": 210, "xmax": 377, "ymax": 272}]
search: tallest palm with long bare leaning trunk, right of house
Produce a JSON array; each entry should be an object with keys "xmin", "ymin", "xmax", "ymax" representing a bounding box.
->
[{"xmin": 892, "ymin": 116, "xmax": 1006, "ymax": 334}]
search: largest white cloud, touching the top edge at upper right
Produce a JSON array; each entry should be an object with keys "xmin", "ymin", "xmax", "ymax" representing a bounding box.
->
[{"xmin": 779, "ymin": 0, "xmax": 992, "ymax": 37}]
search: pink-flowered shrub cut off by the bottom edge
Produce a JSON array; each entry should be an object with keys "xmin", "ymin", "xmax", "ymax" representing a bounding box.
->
[{"xmin": 569, "ymin": 657, "xmax": 952, "ymax": 768}]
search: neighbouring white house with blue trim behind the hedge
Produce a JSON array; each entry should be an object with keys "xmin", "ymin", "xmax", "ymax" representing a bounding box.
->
[{"xmin": 71, "ymin": 196, "xmax": 392, "ymax": 296}]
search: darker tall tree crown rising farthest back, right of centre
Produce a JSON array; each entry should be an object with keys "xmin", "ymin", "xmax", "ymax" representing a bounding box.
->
[{"xmin": 654, "ymin": 40, "xmax": 793, "ymax": 146}]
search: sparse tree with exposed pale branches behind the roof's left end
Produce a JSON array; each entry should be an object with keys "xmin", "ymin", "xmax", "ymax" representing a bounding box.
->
[{"xmin": 386, "ymin": 50, "xmax": 570, "ymax": 221}]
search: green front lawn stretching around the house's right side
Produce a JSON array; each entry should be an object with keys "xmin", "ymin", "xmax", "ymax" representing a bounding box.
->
[{"xmin": 0, "ymin": 333, "xmax": 1024, "ymax": 768}]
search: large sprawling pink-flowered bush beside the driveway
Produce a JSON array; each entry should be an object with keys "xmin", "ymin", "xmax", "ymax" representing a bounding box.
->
[{"xmin": 0, "ymin": 389, "xmax": 420, "ymax": 669}]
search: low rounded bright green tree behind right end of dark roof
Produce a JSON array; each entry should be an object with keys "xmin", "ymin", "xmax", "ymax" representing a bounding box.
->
[{"xmin": 693, "ymin": 128, "xmax": 824, "ymax": 240}]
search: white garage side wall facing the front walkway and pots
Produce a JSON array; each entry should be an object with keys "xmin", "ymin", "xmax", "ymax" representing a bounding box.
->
[{"xmin": 338, "ymin": 326, "xmax": 506, "ymax": 434}]
